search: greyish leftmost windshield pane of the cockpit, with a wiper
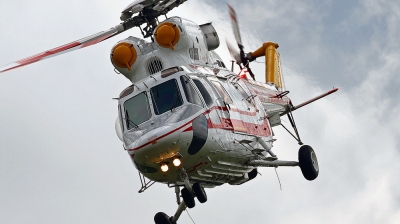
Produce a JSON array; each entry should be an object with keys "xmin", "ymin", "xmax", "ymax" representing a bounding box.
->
[{"xmin": 124, "ymin": 92, "xmax": 151, "ymax": 130}]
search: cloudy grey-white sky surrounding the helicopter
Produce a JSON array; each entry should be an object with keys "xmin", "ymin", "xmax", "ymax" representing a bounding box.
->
[{"xmin": 0, "ymin": 0, "xmax": 400, "ymax": 224}]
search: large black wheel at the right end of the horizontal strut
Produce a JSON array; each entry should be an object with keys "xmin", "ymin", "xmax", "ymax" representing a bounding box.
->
[{"xmin": 299, "ymin": 145, "xmax": 319, "ymax": 180}]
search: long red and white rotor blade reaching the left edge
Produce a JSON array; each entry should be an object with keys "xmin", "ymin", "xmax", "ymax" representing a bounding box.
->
[{"xmin": 0, "ymin": 24, "xmax": 125, "ymax": 73}]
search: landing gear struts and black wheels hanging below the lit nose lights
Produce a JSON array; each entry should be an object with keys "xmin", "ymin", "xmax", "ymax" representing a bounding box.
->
[{"xmin": 154, "ymin": 168, "xmax": 207, "ymax": 224}]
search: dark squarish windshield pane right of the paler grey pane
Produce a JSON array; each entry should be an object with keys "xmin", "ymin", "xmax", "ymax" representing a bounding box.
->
[{"xmin": 150, "ymin": 79, "xmax": 183, "ymax": 115}]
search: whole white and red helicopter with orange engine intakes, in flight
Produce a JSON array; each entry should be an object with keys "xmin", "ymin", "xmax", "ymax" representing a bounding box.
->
[{"xmin": 0, "ymin": 0, "xmax": 337, "ymax": 223}]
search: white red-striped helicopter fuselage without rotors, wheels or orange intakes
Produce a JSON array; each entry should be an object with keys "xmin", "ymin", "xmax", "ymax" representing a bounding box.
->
[{"xmin": 112, "ymin": 17, "xmax": 290, "ymax": 187}]
